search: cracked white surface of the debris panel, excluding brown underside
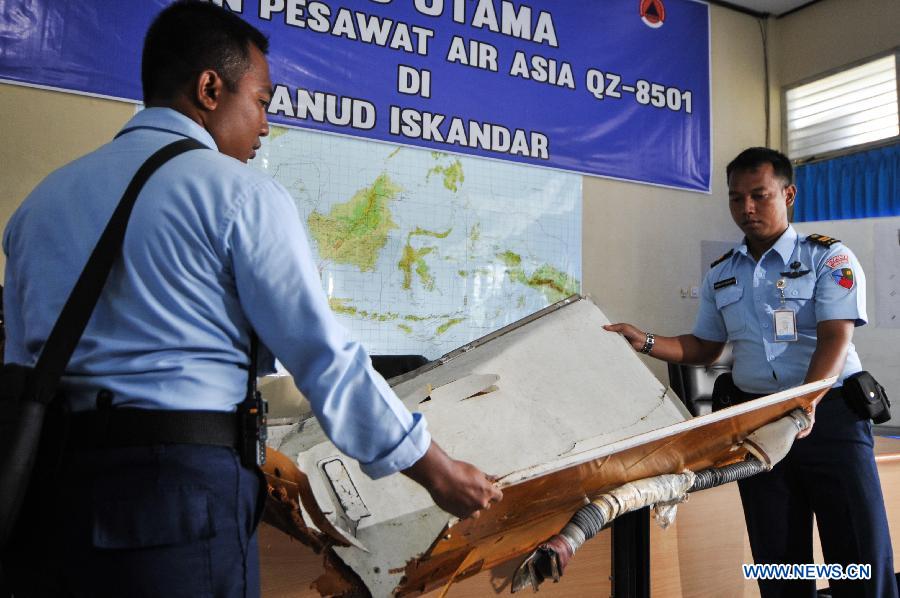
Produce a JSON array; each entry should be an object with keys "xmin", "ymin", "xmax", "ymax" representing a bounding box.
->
[{"xmin": 280, "ymin": 300, "xmax": 687, "ymax": 596}]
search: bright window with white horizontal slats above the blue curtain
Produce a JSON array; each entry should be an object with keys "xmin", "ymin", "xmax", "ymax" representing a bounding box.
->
[{"xmin": 785, "ymin": 54, "xmax": 900, "ymax": 160}]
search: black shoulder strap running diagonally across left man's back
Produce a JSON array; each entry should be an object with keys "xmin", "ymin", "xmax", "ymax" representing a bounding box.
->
[{"xmin": 32, "ymin": 138, "xmax": 206, "ymax": 404}]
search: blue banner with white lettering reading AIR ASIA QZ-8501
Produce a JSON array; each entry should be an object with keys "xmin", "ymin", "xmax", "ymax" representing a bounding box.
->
[{"xmin": 0, "ymin": 0, "xmax": 711, "ymax": 192}]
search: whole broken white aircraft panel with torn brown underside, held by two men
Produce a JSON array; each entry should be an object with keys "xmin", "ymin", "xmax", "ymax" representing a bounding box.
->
[{"xmin": 267, "ymin": 297, "xmax": 827, "ymax": 596}]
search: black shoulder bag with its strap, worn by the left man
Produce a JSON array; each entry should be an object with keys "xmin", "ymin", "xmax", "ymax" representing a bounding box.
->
[{"xmin": 0, "ymin": 138, "xmax": 206, "ymax": 549}]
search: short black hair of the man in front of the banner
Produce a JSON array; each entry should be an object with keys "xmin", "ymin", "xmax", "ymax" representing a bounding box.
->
[{"xmin": 141, "ymin": 0, "xmax": 269, "ymax": 104}]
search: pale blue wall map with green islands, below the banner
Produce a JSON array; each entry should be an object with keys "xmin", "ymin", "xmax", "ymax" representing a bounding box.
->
[{"xmin": 251, "ymin": 127, "xmax": 581, "ymax": 358}]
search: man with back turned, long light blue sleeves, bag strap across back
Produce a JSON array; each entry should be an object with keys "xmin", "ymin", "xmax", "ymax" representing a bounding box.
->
[{"xmin": 3, "ymin": 2, "xmax": 501, "ymax": 597}]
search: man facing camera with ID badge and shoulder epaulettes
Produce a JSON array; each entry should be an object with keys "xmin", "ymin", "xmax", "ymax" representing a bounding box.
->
[{"xmin": 606, "ymin": 148, "xmax": 897, "ymax": 598}]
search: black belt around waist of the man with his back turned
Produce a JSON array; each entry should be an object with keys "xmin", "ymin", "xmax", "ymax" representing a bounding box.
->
[{"xmin": 55, "ymin": 408, "xmax": 240, "ymax": 449}]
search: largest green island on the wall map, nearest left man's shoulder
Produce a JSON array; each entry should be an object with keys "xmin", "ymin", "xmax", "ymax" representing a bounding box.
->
[{"xmin": 307, "ymin": 173, "xmax": 403, "ymax": 272}]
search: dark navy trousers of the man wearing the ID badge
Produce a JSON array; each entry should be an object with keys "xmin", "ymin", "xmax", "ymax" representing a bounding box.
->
[{"xmin": 738, "ymin": 395, "xmax": 897, "ymax": 598}]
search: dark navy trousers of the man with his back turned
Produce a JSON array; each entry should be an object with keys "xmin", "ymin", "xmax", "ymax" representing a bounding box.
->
[{"xmin": 3, "ymin": 445, "xmax": 262, "ymax": 598}]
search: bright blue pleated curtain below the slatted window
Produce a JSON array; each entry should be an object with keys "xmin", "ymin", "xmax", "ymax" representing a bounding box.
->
[{"xmin": 794, "ymin": 143, "xmax": 900, "ymax": 222}]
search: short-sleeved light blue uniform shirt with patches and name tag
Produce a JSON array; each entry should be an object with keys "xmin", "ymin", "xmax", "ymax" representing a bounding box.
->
[{"xmin": 693, "ymin": 226, "xmax": 866, "ymax": 394}]
